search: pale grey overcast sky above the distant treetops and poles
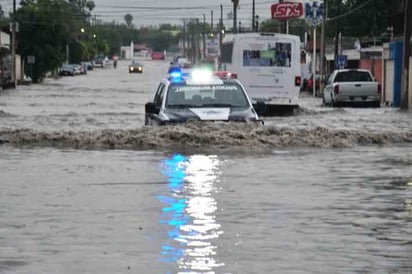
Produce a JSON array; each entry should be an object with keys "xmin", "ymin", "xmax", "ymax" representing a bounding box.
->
[{"xmin": 0, "ymin": 0, "xmax": 278, "ymax": 27}]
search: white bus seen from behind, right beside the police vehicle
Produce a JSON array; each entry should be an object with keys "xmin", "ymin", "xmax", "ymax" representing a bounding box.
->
[{"xmin": 219, "ymin": 33, "xmax": 301, "ymax": 115}]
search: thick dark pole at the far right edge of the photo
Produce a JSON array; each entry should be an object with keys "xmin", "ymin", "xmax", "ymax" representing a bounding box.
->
[{"xmin": 400, "ymin": 0, "xmax": 412, "ymax": 109}]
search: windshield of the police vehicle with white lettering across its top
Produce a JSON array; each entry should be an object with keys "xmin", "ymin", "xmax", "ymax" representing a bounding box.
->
[{"xmin": 166, "ymin": 83, "xmax": 249, "ymax": 108}]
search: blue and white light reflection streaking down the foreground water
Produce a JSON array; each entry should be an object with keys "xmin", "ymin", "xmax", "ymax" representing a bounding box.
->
[{"xmin": 158, "ymin": 154, "xmax": 224, "ymax": 273}]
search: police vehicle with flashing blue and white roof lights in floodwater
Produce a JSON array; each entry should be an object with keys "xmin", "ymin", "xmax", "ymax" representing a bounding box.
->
[{"xmin": 145, "ymin": 68, "xmax": 262, "ymax": 125}]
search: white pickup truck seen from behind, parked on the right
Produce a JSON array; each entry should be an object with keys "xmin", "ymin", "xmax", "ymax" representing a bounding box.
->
[{"xmin": 322, "ymin": 69, "xmax": 381, "ymax": 107}]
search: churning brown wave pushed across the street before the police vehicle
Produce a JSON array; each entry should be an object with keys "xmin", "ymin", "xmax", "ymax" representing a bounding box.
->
[{"xmin": 0, "ymin": 123, "xmax": 412, "ymax": 150}]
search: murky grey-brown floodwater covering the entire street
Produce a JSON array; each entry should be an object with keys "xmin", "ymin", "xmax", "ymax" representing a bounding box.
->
[{"xmin": 0, "ymin": 58, "xmax": 412, "ymax": 274}]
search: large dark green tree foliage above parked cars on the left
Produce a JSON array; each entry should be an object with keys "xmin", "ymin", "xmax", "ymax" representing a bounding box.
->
[{"xmin": 16, "ymin": 0, "xmax": 139, "ymax": 82}]
